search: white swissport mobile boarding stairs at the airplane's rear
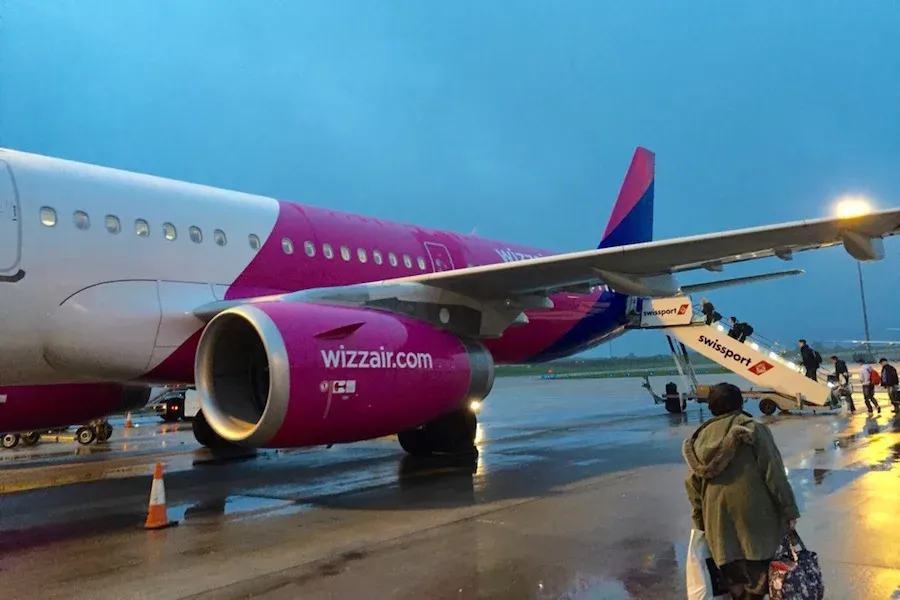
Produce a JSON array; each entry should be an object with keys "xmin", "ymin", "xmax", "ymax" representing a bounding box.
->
[{"xmin": 628, "ymin": 296, "xmax": 841, "ymax": 415}]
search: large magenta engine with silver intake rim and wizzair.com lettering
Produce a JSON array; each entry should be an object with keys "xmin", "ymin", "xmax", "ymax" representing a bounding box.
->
[{"xmin": 194, "ymin": 302, "xmax": 494, "ymax": 448}]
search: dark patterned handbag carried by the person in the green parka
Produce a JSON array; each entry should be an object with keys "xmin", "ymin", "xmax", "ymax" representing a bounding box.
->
[{"xmin": 769, "ymin": 531, "xmax": 825, "ymax": 600}]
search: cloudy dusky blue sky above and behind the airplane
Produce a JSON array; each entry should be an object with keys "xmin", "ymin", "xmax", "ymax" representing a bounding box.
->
[{"xmin": 0, "ymin": 0, "xmax": 900, "ymax": 355}]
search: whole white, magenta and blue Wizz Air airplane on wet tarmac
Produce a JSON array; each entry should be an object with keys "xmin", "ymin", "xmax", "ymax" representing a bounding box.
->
[{"xmin": 0, "ymin": 147, "xmax": 900, "ymax": 455}]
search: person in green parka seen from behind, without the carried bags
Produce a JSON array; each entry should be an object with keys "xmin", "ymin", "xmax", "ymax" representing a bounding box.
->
[{"xmin": 682, "ymin": 383, "xmax": 800, "ymax": 600}]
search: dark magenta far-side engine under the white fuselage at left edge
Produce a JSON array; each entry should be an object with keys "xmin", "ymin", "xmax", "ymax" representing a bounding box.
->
[{"xmin": 0, "ymin": 383, "xmax": 150, "ymax": 433}]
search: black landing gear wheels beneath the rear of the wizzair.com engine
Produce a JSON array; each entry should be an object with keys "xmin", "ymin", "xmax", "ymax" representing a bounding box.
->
[{"xmin": 397, "ymin": 409, "xmax": 478, "ymax": 456}]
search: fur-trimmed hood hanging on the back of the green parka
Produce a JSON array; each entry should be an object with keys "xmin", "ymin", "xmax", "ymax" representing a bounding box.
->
[{"xmin": 681, "ymin": 413, "xmax": 755, "ymax": 479}]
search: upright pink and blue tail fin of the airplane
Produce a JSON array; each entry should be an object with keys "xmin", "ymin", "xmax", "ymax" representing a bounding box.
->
[{"xmin": 597, "ymin": 147, "xmax": 656, "ymax": 248}]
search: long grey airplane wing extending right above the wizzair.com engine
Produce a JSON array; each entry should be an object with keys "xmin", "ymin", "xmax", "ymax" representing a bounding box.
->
[{"xmin": 194, "ymin": 209, "xmax": 900, "ymax": 337}]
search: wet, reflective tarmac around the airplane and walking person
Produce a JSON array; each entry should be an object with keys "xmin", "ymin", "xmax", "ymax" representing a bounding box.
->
[{"xmin": 0, "ymin": 376, "xmax": 900, "ymax": 600}]
